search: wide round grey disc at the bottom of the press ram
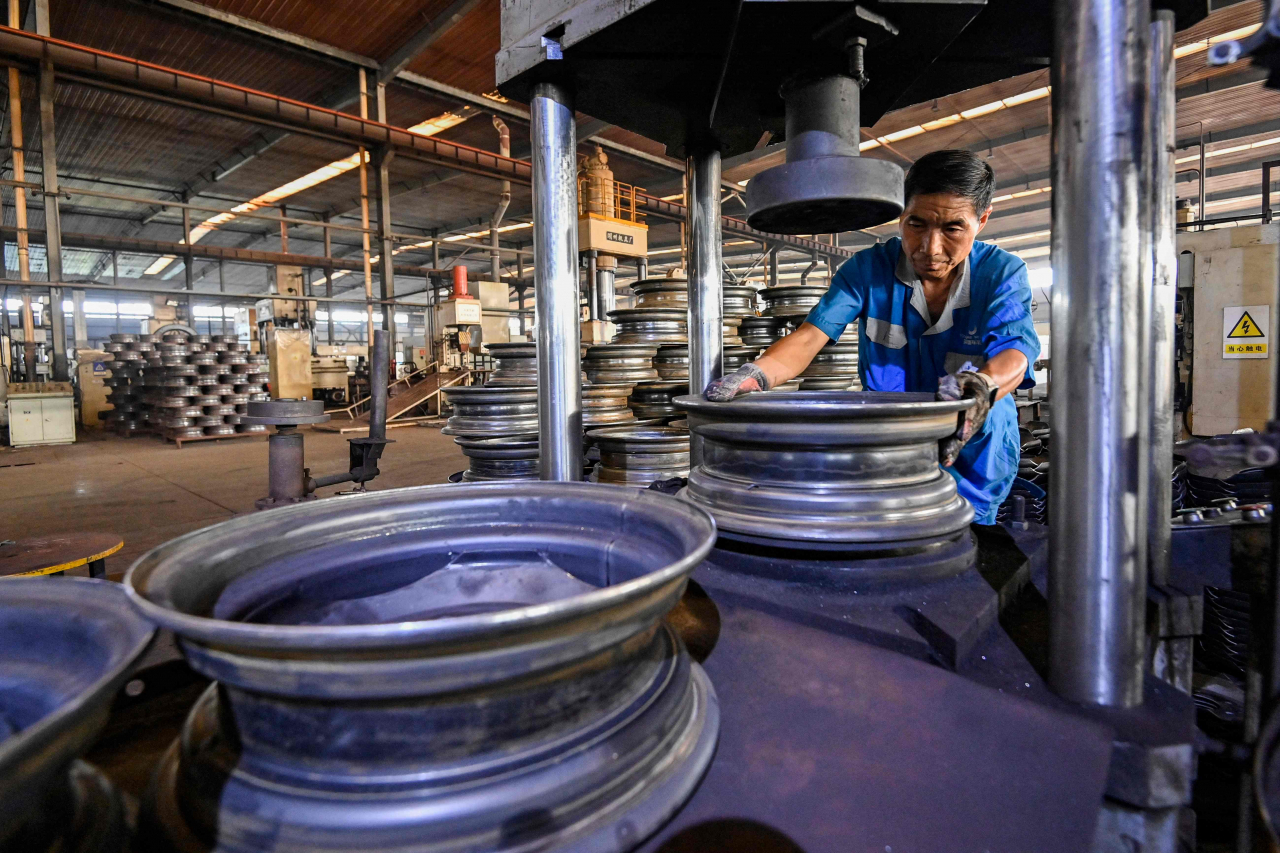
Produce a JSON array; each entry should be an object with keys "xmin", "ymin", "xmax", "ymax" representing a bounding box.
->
[{"xmin": 746, "ymin": 147, "xmax": 904, "ymax": 234}]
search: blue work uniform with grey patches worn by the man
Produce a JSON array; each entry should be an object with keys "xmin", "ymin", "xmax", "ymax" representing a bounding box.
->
[{"xmin": 806, "ymin": 237, "xmax": 1039, "ymax": 524}]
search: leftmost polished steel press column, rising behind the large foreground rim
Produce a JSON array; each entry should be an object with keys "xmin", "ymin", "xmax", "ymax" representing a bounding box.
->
[{"xmin": 529, "ymin": 83, "xmax": 582, "ymax": 480}]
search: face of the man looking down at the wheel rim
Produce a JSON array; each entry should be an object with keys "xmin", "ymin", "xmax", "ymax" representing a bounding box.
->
[{"xmin": 899, "ymin": 192, "xmax": 991, "ymax": 279}]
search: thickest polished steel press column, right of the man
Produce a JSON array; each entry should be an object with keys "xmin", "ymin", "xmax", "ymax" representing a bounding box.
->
[{"xmin": 1048, "ymin": 0, "xmax": 1152, "ymax": 707}]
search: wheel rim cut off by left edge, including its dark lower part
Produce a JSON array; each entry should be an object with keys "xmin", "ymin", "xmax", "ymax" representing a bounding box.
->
[{"xmin": 0, "ymin": 578, "xmax": 155, "ymax": 853}]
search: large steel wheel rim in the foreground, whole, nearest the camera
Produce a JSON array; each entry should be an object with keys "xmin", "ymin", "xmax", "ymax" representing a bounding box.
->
[{"xmin": 125, "ymin": 483, "xmax": 718, "ymax": 852}]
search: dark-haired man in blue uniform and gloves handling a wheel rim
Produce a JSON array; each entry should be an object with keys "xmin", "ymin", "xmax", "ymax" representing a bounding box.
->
[{"xmin": 705, "ymin": 151, "xmax": 1039, "ymax": 524}]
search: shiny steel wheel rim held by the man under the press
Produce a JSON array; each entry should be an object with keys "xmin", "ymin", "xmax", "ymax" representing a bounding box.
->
[{"xmin": 675, "ymin": 391, "xmax": 973, "ymax": 544}]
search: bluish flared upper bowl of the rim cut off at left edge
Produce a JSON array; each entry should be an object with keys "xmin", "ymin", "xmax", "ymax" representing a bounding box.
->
[{"xmin": 0, "ymin": 578, "xmax": 155, "ymax": 849}]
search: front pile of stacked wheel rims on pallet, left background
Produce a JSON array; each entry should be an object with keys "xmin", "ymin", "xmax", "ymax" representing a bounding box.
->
[{"xmin": 142, "ymin": 332, "xmax": 270, "ymax": 438}]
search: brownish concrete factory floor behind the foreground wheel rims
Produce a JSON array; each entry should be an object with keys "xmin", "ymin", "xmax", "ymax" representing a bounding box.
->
[{"xmin": 0, "ymin": 427, "xmax": 466, "ymax": 579}]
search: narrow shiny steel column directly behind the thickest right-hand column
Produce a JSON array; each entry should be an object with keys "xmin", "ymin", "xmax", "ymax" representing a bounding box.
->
[{"xmin": 1143, "ymin": 10, "xmax": 1178, "ymax": 585}]
